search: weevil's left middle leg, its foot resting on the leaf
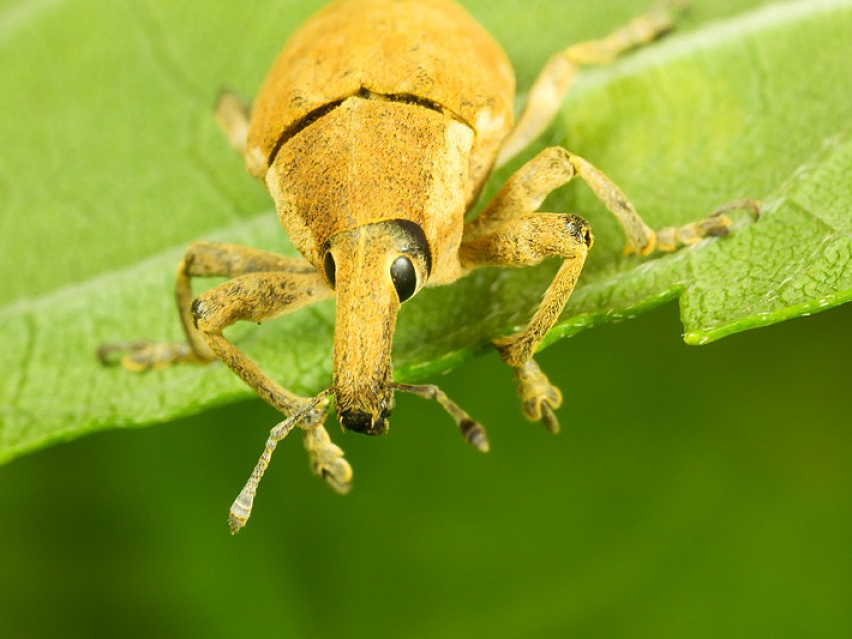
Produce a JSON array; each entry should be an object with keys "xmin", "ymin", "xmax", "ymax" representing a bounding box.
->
[{"xmin": 98, "ymin": 242, "xmax": 316, "ymax": 372}]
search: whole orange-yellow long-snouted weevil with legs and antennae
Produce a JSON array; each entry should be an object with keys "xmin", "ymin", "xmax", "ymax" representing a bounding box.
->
[{"xmin": 100, "ymin": 0, "xmax": 756, "ymax": 532}]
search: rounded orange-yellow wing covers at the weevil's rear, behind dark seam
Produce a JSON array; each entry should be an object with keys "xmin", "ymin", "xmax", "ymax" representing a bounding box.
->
[{"xmin": 247, "ymin": 0, "xmax": 515, "ymax": 198}]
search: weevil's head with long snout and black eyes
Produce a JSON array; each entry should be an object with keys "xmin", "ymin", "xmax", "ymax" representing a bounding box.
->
[{"xmin": 323, "ymin": 220, "xmax": 432, "ymax": 435}]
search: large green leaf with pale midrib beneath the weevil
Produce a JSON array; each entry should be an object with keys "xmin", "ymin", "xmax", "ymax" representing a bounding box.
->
[{"xmin": 0, "ymin": 0, "xmax": 852, "ymax": 459}]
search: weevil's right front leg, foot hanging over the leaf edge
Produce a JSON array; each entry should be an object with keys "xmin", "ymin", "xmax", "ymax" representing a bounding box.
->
[{"xmin": 460, "ymin": 213, "xmax": 592, "ymax": 432}]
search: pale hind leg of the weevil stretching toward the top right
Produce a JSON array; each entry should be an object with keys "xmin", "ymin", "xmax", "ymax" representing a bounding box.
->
[{"xmin": 496, "ymin": 0, "xmax": 686, "ymax": 167}]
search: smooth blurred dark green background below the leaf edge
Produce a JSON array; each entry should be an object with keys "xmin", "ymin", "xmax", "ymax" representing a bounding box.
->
[{"xmin": 0, "ymin": 305, "xmax": 852, "ymax": 638}]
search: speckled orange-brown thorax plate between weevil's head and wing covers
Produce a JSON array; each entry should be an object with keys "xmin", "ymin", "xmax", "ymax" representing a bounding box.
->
[{"xmin": 266, "ymin": 97, "xmax": 474, "ymax": 285}]
